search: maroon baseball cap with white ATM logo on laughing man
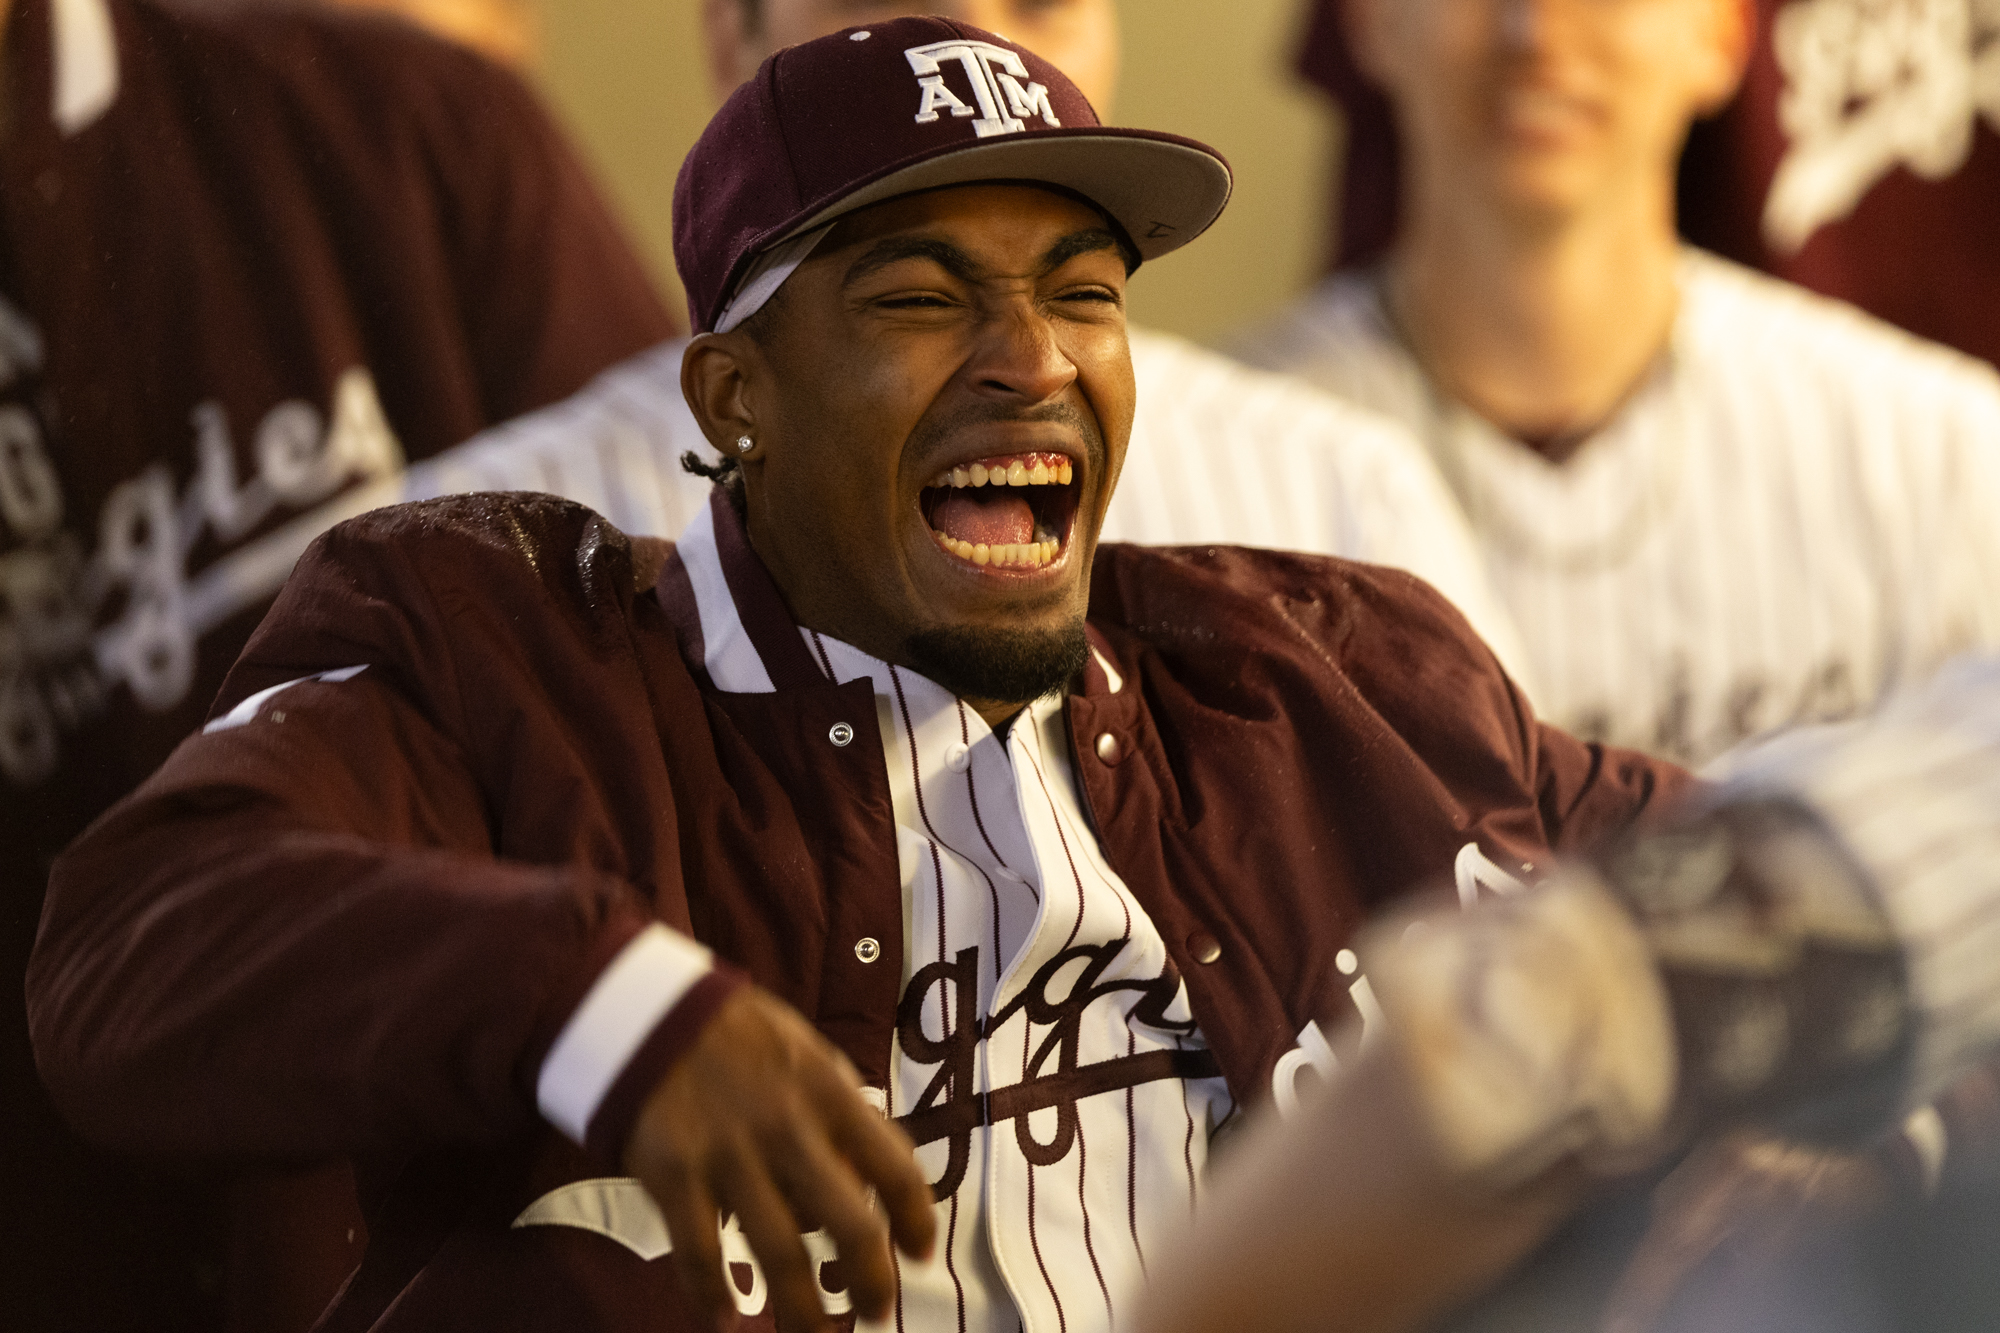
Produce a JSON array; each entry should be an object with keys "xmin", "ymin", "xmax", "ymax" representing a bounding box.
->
[{"xmin": 674, "ymin": 18, "xmax": 1232, "ymax": 332}]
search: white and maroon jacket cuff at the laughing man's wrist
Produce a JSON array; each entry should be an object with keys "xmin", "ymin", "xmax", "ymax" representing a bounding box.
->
[{"xmin": 534, "ymin": 923, "xmax": 744, "ymax": 1161}]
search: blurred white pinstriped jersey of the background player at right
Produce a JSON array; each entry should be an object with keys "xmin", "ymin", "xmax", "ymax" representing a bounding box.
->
[{"xmin": 1242, "ymin": 250, "xmax": 2000, "ymax": 761}]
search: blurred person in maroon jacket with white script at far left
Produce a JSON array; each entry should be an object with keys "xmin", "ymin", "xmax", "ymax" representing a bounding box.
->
[{"xmin": 0, "ymin": 0, "xmax": 674, "ymax": 1333}]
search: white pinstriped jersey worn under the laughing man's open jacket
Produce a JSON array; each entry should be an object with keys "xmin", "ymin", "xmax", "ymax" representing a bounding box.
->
[{"xmin": 678, "ymin": 508, "xmax": 1232, "ymax": 1333}]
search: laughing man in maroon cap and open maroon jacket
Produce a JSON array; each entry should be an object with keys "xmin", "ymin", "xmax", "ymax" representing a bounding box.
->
[{"xmin": 30, "ymin": 18, "xmax": 1684, "ymax": 1333}]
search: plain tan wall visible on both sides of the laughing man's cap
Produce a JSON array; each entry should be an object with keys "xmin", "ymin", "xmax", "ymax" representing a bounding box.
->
[{"xmin": 534, "ymin": 0, "xmax": 1338, "ymax": 340}]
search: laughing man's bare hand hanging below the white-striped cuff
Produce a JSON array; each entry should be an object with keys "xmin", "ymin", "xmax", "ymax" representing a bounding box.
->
[{"xmin": 624, "ymin": 987, "xmax": 936, "ymax": 1329}]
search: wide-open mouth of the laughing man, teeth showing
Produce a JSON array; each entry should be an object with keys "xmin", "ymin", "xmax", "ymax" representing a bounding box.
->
[{"xmin": 920, "ymin": 452, "xmax": 1080, "ymax": 570}]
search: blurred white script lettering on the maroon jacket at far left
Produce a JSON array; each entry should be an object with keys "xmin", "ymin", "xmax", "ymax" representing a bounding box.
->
[{"xmin": 0, "ymin": 338, "xmax": 402, "ymax": 787}]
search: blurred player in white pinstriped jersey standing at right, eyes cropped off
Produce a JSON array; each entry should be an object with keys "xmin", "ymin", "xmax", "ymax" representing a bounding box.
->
[{"xmin": 1238, "ymin": 0, "xmax": 2000, "ymax": 761}]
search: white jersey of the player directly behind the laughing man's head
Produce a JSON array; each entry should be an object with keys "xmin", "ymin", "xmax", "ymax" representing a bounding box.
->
[{"xmin": 404, "ymin": 330, "xmax": 1532, "ymax": 693}]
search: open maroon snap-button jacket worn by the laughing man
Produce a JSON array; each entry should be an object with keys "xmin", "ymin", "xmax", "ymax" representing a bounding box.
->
[{"xmin": 30, "ymin": 496, "xmax": 1686, "ymax": 1331}]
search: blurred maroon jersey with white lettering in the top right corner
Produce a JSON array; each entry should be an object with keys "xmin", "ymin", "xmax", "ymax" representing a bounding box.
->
[{"xmin": 1680, "ymin": 0, "xmax": 2000, "ymax": 362}]
